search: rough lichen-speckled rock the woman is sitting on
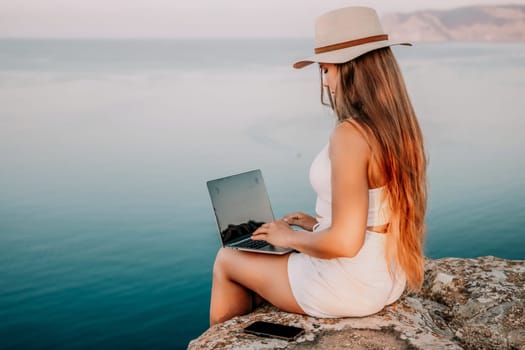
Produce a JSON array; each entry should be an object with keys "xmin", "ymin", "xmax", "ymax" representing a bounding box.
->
[{"xmin": 188, "ymin": 256, "xmax": 525, "ymax": 350}]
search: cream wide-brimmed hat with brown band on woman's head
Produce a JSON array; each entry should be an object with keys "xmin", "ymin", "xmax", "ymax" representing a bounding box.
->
[{"xmin": 293, "ymin": 7, "xmax": 412, "ymax": 69}]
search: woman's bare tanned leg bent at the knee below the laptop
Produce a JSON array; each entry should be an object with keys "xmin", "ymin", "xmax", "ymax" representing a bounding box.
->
[{"xmin": 210, "ymin": 248, "xmax": 304, "ymax": 325}]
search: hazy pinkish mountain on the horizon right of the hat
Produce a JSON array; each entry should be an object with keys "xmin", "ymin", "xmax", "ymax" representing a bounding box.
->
[{"xmin": 382, "ymin": 5, "xmax": 525, "ymax": 41}]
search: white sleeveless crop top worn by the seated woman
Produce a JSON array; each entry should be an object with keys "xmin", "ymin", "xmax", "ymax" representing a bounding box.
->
[{"xmin": 310, "ymin": 144, "xmax": 390, "ymax": 226}]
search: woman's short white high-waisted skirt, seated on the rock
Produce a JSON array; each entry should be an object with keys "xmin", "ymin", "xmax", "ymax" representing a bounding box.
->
[{"xmin": 288, "ymin": 223, "xmax": 406, "ymax": 318}]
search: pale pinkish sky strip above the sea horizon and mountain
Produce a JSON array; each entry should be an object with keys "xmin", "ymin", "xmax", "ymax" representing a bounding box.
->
[{"xmin": 0, "ymin": 0, "xmax": 525, "ymax": 38}]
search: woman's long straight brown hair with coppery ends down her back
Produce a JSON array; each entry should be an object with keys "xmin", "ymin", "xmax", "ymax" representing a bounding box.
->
[{"xmin": 330, "ymin": 47, "xmax": 427, "ymax": 291}]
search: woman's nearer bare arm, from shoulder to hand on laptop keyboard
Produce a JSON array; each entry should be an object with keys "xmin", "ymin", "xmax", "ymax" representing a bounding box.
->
[{"xmin": 254, "ymin": 123, "xmax": 370, "ymax": 259}]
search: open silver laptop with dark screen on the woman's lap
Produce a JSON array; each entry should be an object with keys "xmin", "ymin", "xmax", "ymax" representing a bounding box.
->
[{"xmin": 206, "ymin": 169, "xmax": 293, "ymax": 255}]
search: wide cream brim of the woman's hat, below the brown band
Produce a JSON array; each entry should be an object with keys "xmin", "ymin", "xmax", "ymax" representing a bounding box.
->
[{"xmin": 293, "ymin": 40, "xmax": 412, "ymax": 69}]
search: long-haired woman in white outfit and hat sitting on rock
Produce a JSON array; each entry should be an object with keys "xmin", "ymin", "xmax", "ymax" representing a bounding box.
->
[{"xmin": 210, "ymin": 7, "xmax": 427, "ymax": 325}]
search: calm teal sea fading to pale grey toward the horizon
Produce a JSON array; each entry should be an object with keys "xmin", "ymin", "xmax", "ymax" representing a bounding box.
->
[{"xmin": 0, "ymin": 39, "xmax": 525, "ymax": 349}]
